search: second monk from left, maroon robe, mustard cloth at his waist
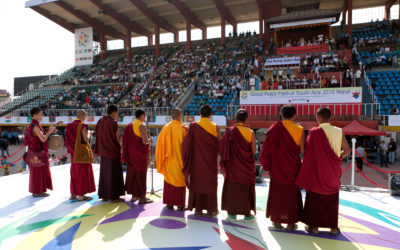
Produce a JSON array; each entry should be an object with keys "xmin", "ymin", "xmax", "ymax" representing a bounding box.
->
[{"xmin": 65, "ymin": 110, "xmax": 96, "ymax": 201}]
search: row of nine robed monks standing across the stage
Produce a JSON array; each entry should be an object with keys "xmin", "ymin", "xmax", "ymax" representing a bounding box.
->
[{"xmin": 25, "ymin": 105, "xmax": 350, "ymax": 235}]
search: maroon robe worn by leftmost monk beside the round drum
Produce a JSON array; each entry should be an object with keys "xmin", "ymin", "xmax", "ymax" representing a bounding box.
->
[{"xmin": 24, "ymin": 119, "xmax": 53, "ymax": 194}]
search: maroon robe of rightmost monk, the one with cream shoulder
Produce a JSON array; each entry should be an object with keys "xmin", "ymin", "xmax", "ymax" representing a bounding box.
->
[{"xmin": 296, "ymin": 128, "xmax": 342, "ymax": 228}]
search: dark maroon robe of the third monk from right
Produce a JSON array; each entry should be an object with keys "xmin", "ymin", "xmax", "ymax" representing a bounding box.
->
[{"xmin": 219, "ymin": 127, "xmax": 256, "ymax": 216}]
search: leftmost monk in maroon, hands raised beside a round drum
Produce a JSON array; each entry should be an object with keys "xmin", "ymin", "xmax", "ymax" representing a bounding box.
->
[{"xmin": 24, "ymin": 108, "xmax": 56, "ymax": 197}]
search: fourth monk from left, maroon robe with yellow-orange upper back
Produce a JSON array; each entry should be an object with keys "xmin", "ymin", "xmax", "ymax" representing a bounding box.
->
[{"xmin": 122, "ymin": 109, "xmax": 153, "ymax": 204}]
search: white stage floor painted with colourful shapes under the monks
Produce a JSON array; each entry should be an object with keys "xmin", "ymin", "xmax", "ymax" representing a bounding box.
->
[{"xmin": 0, "ymin": 165, "xmax": 400, "ymax": 250}]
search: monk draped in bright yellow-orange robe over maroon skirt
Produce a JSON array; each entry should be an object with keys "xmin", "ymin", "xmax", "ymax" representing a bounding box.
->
[{"xmin": 156, "ymin": 108, "xmax": 188, "ymax": 211}]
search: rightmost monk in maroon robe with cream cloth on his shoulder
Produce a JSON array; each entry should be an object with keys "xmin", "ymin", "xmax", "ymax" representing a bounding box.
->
[{"xmin": 296, "ymin": 107, "xmax": 350, "ymax": 236}]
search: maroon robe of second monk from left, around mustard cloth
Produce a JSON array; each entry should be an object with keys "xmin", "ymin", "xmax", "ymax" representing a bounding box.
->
[{"xmin": 65, "ymin": 120, "xmax": 96, "ymax": 196}]
